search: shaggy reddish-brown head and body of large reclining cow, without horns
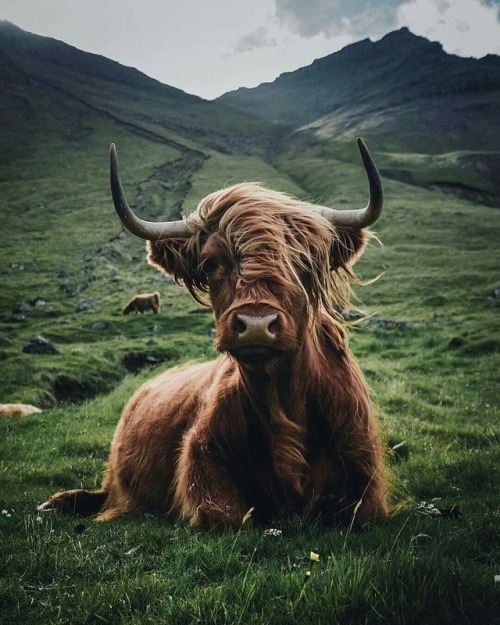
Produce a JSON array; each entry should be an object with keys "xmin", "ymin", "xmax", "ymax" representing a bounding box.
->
[{"xmin": 41, "ymin": 184, "xmax": 387, "ymax": 528}]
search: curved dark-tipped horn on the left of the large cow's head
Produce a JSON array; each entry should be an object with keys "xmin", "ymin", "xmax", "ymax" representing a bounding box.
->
[{"xmin": 109, "ymin": 143, "xmax": 191, "ymax": 241}]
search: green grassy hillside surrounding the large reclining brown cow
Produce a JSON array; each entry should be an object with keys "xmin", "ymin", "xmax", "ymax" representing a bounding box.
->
[{"xmin": 0, "ymin": 22, "xmax": 500, "ymax": 625}]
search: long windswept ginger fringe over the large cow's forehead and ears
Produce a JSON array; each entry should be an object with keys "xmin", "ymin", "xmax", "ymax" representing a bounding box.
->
[{"xmin": 149, "ymin": 183, "xmax": 371, "ymax": 354}]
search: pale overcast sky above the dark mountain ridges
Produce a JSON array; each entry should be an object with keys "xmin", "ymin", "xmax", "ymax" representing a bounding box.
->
[{"xmin": 0, "ymin": 0, "xmax": 500, "ymax": 99}]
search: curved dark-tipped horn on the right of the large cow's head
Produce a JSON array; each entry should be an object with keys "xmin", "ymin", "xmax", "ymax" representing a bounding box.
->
[{"xmin": 318, "ymin": 138, "xmax": 384, "ymax": 228}]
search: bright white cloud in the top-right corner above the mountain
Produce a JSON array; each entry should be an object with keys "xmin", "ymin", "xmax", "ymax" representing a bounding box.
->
[{"xmin": 397, "ymin": 0, "xmax": 500, "ymax": 57}]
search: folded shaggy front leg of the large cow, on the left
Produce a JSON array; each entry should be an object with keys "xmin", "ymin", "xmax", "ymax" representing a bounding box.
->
[{"xmin": 175, "ymin": 428, "xmax": 249, "ymax": 528}]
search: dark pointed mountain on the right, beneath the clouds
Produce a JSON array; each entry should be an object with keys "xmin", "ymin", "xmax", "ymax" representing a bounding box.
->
[{"xmin": 217, "ymin": 28, "xmax": 500, "ymax": 146}]
